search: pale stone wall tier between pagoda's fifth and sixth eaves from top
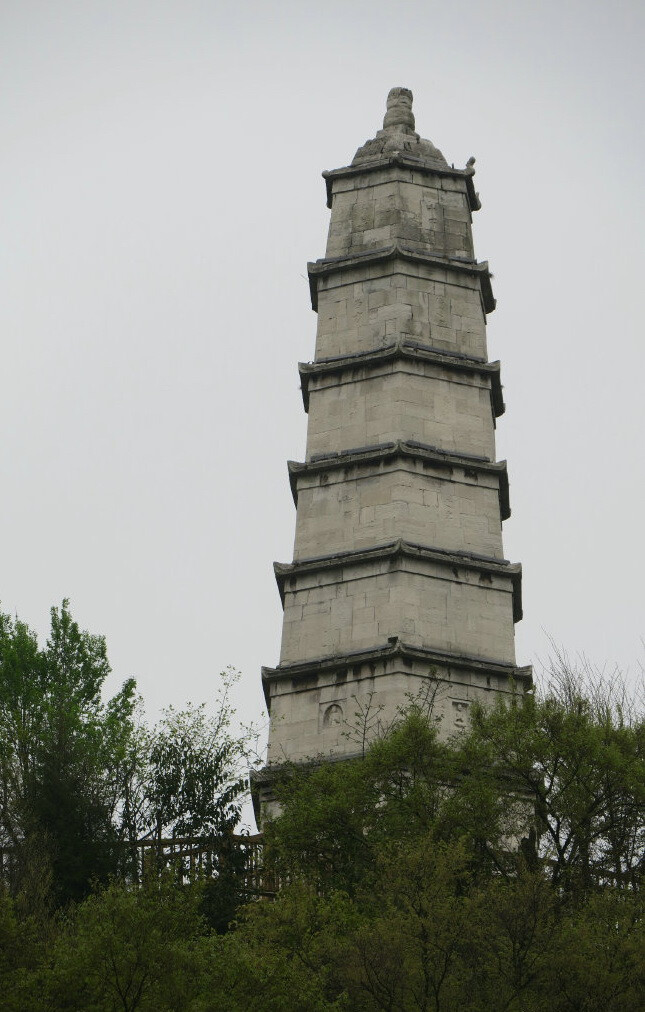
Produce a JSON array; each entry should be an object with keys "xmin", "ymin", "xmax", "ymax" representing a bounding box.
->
[{"xmin": 280, "ymin": 558, "xmax": 514, "ymax": 664}]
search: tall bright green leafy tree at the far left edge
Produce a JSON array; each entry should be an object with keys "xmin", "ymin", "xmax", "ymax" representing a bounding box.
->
[{"xmin": 0, "ymin": 601, "xmax": 135, "ymax": 904}]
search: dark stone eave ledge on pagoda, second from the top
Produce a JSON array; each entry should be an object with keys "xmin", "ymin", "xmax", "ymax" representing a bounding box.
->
[{"xmin": 307, "ymin": 243, "xmax": 496, "ymax": 313}]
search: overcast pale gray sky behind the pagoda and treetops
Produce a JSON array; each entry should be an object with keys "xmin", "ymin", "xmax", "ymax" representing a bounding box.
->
[{"xmin": 0, "ymin": 0, "xmax": 645, "ymax": 744}]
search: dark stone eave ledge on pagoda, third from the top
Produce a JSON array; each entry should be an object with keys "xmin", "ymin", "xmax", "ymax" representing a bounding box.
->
[{"xmin": 298, "ymin": 341, "xmax": 505, "ymax": 418}]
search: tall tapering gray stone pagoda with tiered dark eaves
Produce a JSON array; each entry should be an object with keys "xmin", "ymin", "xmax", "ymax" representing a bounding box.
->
[{"xmin": 256, "ymin": 88, "xmax": 531, "ymax": 812}]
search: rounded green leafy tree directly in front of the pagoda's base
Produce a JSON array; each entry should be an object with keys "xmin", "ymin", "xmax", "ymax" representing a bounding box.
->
[{"xmin": 264, "ymin": 706, "xmax": 467, "ymax": 894}]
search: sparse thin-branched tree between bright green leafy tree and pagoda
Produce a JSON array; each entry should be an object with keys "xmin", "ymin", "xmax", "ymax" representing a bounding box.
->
[{"xmin": 114, "ymin": 668, "xmax": 259, "ymax": 932}]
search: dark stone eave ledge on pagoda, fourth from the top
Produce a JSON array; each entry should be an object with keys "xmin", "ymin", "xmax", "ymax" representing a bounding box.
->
[{"xmin": 287, "ymin": 439, "xmax": 510, "ymax": 520}]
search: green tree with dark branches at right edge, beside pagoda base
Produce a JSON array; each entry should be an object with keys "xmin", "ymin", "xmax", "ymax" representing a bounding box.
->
[{"xmin": 449, "ymin": 667, "xmax": 645, "ymax": 895}]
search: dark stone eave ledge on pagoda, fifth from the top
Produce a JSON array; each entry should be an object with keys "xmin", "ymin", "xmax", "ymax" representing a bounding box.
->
[{"xmin": 273, "ymin": 538, "xmax": 522, "ymax": 622}]
